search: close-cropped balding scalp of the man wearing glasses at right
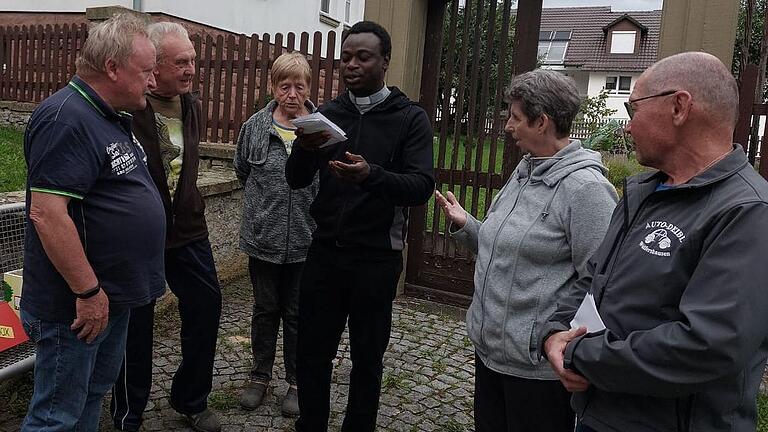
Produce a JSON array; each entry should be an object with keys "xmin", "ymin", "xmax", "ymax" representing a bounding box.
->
[{"xmin": 643, "ymin": 52, "xmax": 739, "ymax": 126}]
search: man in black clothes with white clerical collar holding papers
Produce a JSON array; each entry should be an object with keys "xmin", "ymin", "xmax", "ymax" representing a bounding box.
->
[{"xmin": 286, "ymin": 21, "xmax": 434, "ymax": 432}]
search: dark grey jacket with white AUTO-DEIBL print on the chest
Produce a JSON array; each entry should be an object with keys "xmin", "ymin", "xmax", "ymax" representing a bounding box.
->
[{"xmin": 542, "ymin": 146, "xmax": 768, "ymax": 432}]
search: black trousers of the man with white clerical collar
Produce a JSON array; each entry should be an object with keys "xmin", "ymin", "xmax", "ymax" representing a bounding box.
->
[{"xmin": 296, "ymin": 243, "xmax": 402, "ymax": 432}]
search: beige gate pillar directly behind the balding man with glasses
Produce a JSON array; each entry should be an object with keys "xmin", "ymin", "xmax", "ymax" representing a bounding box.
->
[{"xmin": 659, "ymin": 0, "xmax": 739, "ymax": 68}]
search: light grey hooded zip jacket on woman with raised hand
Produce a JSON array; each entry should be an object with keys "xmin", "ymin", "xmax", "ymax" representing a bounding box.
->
[{"xmin": 453, "ymin": 141, "xmax": 618, "ymax": 380}]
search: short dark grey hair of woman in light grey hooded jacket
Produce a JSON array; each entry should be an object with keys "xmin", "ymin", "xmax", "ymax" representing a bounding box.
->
[{"xmin": 504, "ymin": 69, "xmax": 581, "ymax": 138}]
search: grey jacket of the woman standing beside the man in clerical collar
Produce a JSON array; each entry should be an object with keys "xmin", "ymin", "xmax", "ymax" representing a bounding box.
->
[{"xmin": 234, "ymin": 101, "xmax": 318, "ymax": 264}]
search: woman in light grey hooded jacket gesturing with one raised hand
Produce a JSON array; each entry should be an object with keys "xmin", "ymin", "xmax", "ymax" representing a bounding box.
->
[{"xmin": 435, "ymin": 70, "xmax": 618, "ymax": 432}]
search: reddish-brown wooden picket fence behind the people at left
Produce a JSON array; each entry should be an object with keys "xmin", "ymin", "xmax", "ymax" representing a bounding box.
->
[{"xmin": 0, "ymin": 24, "xmax": 344, "ymax": 143}]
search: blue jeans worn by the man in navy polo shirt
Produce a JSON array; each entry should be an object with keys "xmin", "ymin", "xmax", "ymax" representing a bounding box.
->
[{"xmin": 21, "ymin": 309, "xmax": 130, "ymax": 432}]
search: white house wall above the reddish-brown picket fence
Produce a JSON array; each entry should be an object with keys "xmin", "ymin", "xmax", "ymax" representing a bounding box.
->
[{"xmin": 0, "ymin": 0, "xmax": 365, "ymax": 55}]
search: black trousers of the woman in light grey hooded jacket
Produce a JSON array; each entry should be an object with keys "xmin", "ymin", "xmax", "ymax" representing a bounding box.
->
[{"xmin": 475, "ymin": 355, "xmax": 576, "ymax": 432}]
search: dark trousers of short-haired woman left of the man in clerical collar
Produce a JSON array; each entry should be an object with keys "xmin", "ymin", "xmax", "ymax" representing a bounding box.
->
[{"xmin": 248, "ymin": 258, "xmax": 304, "ymax": 384}]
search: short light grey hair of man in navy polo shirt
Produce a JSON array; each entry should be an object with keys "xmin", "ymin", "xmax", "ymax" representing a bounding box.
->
[{"xmin": 75, "ymin": 13, "xmax": 149, "ymax": 75}]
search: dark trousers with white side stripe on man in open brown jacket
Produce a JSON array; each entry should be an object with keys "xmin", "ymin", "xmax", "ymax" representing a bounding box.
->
[{"xmin": 110, "ymin": 239, "xmax": 221, "ymax": 430}]
